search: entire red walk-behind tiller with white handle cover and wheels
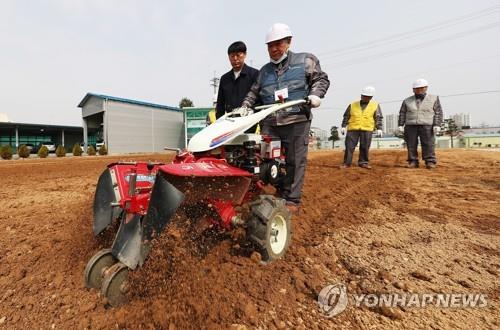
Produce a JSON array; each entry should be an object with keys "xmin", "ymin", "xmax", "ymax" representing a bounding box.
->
[{"xmin": 84, "ymin": 100, "xmax": 300, "ymax": 306}]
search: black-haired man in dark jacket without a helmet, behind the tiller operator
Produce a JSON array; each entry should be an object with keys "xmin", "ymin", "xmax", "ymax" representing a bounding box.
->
[{"xmin": 216, "ymin": 41, "xmax": 259, "ymax": 118}]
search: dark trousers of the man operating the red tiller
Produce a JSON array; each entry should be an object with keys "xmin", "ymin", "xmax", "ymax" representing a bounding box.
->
[{"xmin": 261, "ymin": 121, "xmax": 311, "ymax": 204}]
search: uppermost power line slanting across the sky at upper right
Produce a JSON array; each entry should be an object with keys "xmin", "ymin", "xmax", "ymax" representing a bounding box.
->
[{"xmin": 318, "ymin": 5, "xmax": 500, "ymax": 58}]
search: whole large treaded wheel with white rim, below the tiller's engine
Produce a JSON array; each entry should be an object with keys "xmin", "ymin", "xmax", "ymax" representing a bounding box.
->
[{"xmin": 247, "ymin": 195, "xmax": 292, "ymax": 264}]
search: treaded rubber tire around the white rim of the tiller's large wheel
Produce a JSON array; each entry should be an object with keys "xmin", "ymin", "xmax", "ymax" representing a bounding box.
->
[{"xmin": 247, "ymin": 195, "xmax": 292, "ymax": 264}]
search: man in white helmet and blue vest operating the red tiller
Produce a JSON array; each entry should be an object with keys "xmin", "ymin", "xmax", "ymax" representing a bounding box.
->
[{"xmin": 242, "ymin": 23, "xmax": 330, "ymax": 212}]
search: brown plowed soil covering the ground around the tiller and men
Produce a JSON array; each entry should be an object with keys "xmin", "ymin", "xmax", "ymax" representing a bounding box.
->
[{"xmin": 0, "ymin": 150, "xmax": 500, "ymax": 329}]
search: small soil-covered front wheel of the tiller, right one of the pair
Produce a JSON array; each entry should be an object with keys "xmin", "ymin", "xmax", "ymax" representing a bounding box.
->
[{"xmin": 101, "ymin": 262, "xmax": 128, "ymax": 307}]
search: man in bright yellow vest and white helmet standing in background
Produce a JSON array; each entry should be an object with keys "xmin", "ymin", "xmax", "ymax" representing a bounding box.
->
[{"xmin": 340, "ymin": 86, "xmax": 383, "ymax": 169}]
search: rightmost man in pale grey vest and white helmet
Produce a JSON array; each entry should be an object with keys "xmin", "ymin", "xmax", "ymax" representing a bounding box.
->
[{"xmin": 398, "ymin": 79, "xmax": 443, "ymax": 169}]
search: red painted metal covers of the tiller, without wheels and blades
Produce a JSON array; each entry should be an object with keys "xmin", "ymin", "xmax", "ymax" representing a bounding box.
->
[{"xmin": 103, "ymin": 136, "xmax": 282, "ymax": 230}]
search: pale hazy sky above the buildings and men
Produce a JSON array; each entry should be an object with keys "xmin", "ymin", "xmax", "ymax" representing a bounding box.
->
[{"xmin": 0, "ymin": 0, "xmax": 500, "ymax": 129}]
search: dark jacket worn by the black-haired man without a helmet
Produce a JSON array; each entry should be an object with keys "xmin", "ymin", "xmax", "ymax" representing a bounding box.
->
[{"xmin": 216, "ymin": 64, "xmax": 259, "ymax": 118}]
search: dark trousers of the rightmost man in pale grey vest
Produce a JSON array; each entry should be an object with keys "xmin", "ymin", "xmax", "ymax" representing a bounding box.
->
[{"xmin": 405, "ymin": 125, "xmax": 437, "ymax": 165}]
